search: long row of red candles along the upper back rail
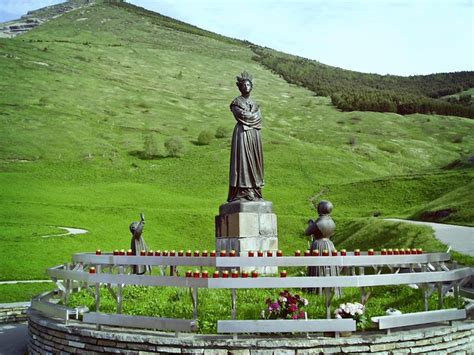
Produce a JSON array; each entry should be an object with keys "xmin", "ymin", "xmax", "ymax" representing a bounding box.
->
[{"xmin": 95, "ymin": 248, "xmax": 423, "ymax": 257}]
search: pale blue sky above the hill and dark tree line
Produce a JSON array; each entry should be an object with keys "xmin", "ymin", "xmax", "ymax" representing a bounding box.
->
[{"xmin": 0, "ymin": 0, "xmax": 474, "ymax": 76}]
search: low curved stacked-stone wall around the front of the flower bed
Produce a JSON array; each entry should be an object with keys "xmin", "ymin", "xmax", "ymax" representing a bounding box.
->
[{"xmin": 28, "ymin": 310, "xmax": 474, "ymax": 355}]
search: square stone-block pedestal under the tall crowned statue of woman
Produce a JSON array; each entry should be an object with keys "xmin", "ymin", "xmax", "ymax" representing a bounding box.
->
[{"xmin": 216, "ymin": 201, "xmax": 278, "ymax": 274}]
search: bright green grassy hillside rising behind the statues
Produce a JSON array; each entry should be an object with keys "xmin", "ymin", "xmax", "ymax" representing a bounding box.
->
[{"xmin": 0, "ymin": 4, "xmax": 474, "ymax": 300}]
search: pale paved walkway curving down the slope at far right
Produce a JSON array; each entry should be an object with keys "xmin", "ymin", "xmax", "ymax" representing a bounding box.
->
[{"xmin": 386, "ymin": 218, "xmax": 474, "ymax": 256}]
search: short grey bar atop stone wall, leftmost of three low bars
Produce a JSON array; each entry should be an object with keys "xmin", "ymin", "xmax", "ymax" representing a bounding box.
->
[{"xmin": 83, "ymin": 312, "xmax": 197, "ymax": 332}]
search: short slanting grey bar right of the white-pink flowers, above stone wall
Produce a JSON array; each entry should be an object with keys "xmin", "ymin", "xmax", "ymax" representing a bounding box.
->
[{"xmin": 372, "ymin": 308, "xmax": 466, "ymax": 329}]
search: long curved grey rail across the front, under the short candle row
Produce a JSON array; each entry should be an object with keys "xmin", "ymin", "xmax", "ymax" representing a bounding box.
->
[{"xmin": 47, "ymin": 267, "xmax": 474, "ymax": 288}]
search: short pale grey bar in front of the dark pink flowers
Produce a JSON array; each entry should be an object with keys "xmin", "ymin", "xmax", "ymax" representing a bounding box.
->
[{"xmin": 217, "ymin": 319, "xmax": 356, "ymax": 333}]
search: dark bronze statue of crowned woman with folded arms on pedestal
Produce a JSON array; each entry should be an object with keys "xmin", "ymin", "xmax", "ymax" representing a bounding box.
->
[{"xmin": 227, "ymin": 72, "xmax": 264, "ymax": 202}]
